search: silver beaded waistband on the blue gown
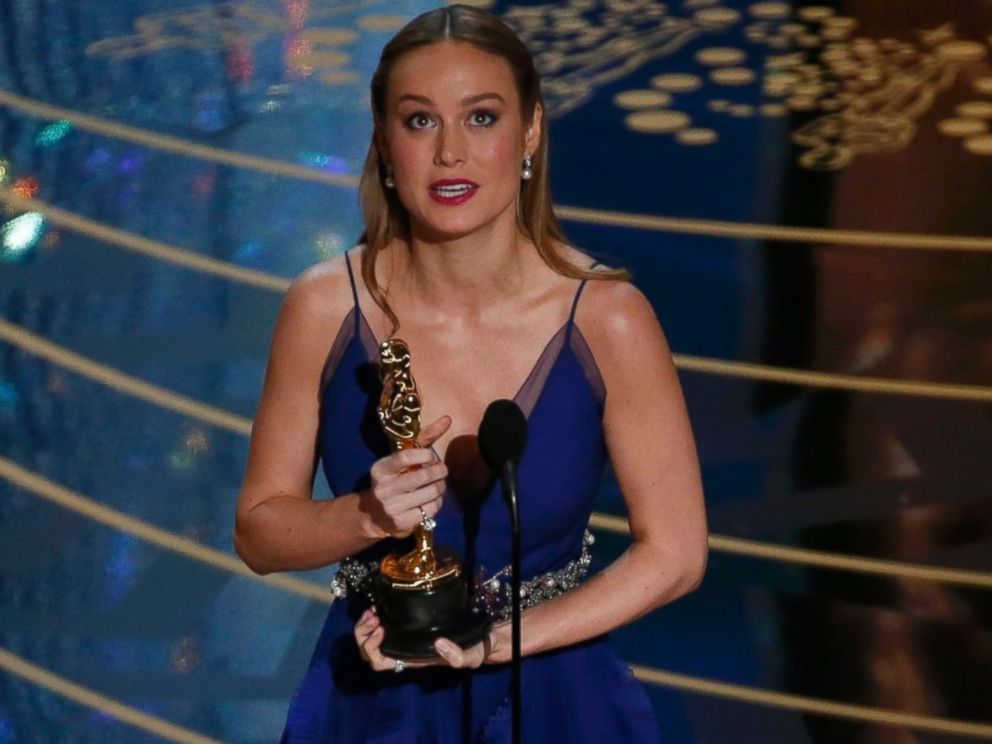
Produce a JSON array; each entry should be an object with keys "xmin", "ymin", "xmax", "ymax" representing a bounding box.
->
[{"xmin": 331, "ymin": 530, "xmax": 595, "ymax": 620}]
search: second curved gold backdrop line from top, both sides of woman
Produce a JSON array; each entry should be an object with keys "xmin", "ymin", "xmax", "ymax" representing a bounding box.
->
[{"xmin": 0, "ymin": 188, "xmax": 992, "ymax": 402}]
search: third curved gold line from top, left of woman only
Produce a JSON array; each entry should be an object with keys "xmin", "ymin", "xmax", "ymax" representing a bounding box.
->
[{"xmin": 0, "ymin": 318, "xmax": 251, "ymax": 435}]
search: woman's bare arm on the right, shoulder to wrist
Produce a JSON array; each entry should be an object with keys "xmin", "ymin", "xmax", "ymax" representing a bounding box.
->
[{"xmin": 512, "ymin": 281, "xmax": 707, "ymax": 661}]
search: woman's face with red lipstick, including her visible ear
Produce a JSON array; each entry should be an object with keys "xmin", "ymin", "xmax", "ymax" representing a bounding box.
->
[{"xmin": 379, "ymin": 41, "xmax": 541, "ymax": 239}]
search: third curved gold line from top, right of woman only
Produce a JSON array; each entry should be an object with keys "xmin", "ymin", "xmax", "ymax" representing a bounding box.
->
[{"xmin": 589, "ymin": 512, "xmax": 992, "ymax": 589}]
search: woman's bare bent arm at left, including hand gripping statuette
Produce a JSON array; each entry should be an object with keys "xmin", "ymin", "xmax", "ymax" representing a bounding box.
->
[{"xmin": 234, "ymin": 260, "xmax": 450, "ymax": 573}]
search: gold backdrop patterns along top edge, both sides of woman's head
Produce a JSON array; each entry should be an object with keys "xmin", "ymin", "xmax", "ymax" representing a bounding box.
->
[{"xmin": 87, "ymin": 0, "xmax": 992, "ymax": 170}]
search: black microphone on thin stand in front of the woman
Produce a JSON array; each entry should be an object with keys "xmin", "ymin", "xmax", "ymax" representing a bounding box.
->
[{"xmin": 479, "ymin": 400, "xmax": 527, "ymax": 744}]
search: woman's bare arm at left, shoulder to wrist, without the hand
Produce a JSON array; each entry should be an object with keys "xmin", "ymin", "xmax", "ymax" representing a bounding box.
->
[{"xmin": 234, "ymin": 264, "xmax": 381, "ymax": 573}]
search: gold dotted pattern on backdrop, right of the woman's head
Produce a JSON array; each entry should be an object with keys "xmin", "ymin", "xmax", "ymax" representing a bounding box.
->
[{"xmin": 505, "ymin": 0, "xmax": 992, "ymax": 170}]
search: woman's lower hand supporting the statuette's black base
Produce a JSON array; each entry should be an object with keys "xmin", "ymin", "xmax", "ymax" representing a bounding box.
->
[{"xmin": 355, "ymin": 610, "xmax": 510, "ymax": 672}]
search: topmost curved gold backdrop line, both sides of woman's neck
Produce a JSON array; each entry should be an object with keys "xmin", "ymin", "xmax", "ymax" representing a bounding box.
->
[{"xmin": 0, "ymin": 89, "xmax": 992, "ymax": 253}]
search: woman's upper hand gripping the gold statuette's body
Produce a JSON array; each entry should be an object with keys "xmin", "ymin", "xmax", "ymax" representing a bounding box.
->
[{"xmin": 360, "ymin": 416, "xmax": 451, "ymax": 537}]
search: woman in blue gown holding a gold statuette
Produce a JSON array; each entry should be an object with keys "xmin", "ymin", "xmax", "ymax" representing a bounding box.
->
[{"xmin": 235, "ymin": 6, "xmax": 706, "ymax": 742}]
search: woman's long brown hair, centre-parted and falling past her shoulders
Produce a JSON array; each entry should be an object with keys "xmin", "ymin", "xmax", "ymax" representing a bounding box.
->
[{"xmin": 358, "ymin": 5, "xmax": 630, "ymax": 333}]
